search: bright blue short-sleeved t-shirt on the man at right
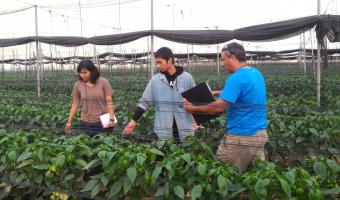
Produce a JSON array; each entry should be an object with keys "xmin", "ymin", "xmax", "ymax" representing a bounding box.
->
[{"xmin": 220, "ymin": 67, "xmax": 267, "ymax": 135}]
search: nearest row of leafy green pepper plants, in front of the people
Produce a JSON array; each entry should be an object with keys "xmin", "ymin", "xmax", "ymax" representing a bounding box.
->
[{"xmin": 0, "ymin": 131, "xmax": 340, "ymax": 199}]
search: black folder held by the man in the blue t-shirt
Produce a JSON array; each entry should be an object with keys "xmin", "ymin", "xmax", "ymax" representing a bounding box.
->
[{"xmin": 182, "ymin": 81, "xmax": 222, "ymax": 125}]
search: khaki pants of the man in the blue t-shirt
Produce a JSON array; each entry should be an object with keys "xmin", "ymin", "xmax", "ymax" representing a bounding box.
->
[{"xmin": 216, "ymin": 130, "xmax": 268, "ymax": 171}]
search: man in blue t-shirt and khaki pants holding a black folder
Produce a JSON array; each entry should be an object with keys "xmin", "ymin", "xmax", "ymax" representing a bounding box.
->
[{"xmin": 184, "ymin": 42, "xmax": 268, "ymax": 170}]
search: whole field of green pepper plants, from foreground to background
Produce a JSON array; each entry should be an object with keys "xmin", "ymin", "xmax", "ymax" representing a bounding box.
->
[{"xmin": 0, "ymin": 65, "xmax": 340, "ymax": 199}]
